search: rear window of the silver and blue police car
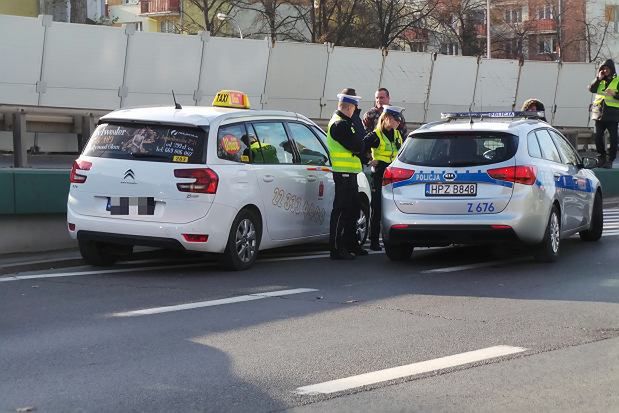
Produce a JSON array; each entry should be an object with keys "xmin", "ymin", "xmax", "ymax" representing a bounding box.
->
[{"xmin": 398, "ymin": 132, "xmax": 518, "ymax": 167}]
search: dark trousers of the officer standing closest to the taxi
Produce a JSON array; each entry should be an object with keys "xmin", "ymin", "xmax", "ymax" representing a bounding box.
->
[{"xmin": 329, "ymin": 172, "xmax": 361, "ymax": 252}]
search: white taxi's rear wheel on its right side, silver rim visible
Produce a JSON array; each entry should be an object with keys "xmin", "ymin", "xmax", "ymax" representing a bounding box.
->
[{"xmin": 221, "ymin": 209, "xmax": 260, "ymax": 271}]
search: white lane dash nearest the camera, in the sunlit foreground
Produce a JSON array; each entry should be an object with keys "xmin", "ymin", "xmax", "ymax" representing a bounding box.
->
[{"xmin": 295, "ymin": 346, "xmax": 527, "ymax": 395}]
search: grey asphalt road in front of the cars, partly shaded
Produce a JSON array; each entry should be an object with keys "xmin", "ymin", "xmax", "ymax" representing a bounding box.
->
[{"xmin": 0, "ymin": 229, "xmax": 619, "ymax": 412}]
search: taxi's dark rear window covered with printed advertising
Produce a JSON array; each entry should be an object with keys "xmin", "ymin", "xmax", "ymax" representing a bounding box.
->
[{"xmin": 83, "ymin": 123, "xmax": 207, "ymax": 163}]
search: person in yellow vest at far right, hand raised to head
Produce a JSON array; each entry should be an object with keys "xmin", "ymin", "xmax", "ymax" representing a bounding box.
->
[{"xmin": 589, "ymin": 59, "xmax": 619, "ymax": 168}]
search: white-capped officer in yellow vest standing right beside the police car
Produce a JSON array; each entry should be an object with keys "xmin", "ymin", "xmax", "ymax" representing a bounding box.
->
[{"xmin": 364, "ymin": 105, "xmax": 403, "ymax": 251}]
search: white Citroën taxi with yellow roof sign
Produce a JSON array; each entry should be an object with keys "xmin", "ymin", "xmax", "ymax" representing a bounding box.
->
[{"xmin": 67, "ymin": 91, "xmax": 370, "ymax": 270}]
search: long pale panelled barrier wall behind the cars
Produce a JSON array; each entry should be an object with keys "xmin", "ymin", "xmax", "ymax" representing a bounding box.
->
[{"xmin": 0, "ymin": 15, "xmax": 595, "ymax": 127}]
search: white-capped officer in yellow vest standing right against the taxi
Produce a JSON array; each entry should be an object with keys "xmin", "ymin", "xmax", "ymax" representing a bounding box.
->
[{"xmin": 327, "ymin": 88, "xmax": 368, "ymax": 260}]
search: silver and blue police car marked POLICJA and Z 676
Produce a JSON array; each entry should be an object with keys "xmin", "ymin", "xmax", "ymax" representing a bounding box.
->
[{"xmin": 382, "ymin": 112, "xmax": 603, "ymax": 261}]
